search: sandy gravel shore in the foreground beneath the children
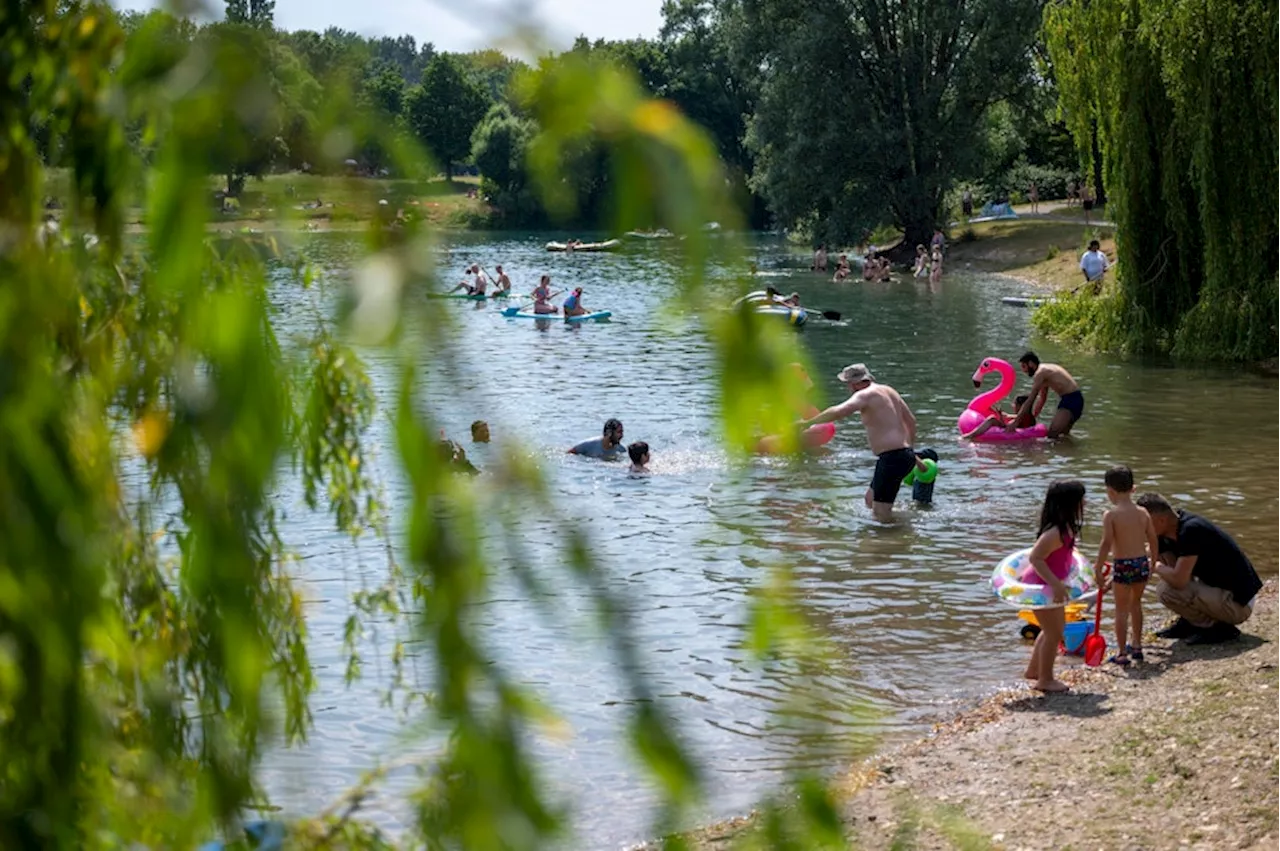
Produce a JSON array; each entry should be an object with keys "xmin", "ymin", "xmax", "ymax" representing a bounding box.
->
[{"xmin": 690, "ymin": 580, "xmax": 1280, "ymax": 851}]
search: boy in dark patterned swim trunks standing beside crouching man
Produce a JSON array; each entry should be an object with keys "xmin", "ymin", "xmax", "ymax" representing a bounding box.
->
[{"xmin": 1093, "ymin": 467, "xmax": 1160, "ymax": 665}]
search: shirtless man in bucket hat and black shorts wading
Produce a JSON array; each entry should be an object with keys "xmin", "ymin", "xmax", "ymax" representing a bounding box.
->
[{"xmin": 800, "ymin": 363, "xmax": 924, "ymax": 521}]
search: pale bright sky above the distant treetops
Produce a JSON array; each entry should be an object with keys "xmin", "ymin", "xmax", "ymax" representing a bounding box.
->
[{"xmin": 111, "ymin": 0, "xmax": 662, "ymax": 55}]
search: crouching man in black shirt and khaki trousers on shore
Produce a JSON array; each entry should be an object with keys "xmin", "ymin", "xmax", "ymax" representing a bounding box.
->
[{"xmin": 1138, "ymin": 494, "xmax": 1262, "ymax": 644}]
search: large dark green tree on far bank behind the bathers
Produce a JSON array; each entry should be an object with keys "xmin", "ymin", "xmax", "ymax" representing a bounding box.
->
[{"xmin": 730, "ymin": 0, "xmax": 1041, "ymax": 247}]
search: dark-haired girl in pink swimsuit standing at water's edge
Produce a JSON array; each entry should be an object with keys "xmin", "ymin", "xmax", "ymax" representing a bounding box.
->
[{"xmin": 1023, "ymin": 481, "xmax": 1084, "ymax": 692}]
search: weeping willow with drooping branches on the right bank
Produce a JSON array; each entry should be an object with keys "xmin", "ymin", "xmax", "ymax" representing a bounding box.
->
[{"xmin": 1044, "ymin": 0, "xmax": 1280, "ymax": 360}]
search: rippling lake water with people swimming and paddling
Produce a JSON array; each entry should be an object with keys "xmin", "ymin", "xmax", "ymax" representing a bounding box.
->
[{"xmin": 264, "ymin": 234, "xmax": 1280, "ymax": 848}]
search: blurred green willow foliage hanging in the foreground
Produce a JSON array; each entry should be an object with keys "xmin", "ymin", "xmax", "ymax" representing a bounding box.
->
[{"xmin": 0, "ymin": 0, "xmax": 860, "ymax": 851}]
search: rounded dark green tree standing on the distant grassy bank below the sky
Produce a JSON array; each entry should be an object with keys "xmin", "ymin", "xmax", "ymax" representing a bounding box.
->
[{"xmin": 404, "ymin": 54, "xmax": 489, "ymax": 180}]
